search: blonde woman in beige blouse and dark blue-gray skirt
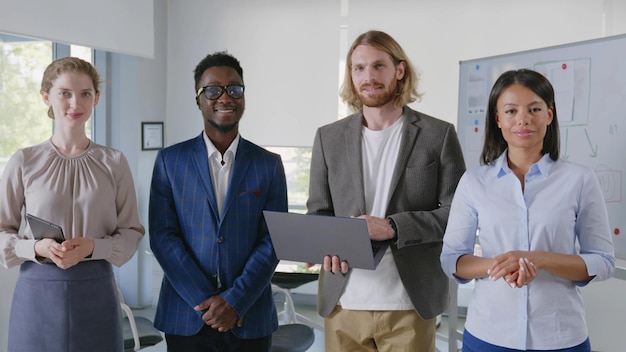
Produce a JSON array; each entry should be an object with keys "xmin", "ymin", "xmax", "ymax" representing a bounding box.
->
[{"xmin": 0, "ymin": 57, "xmax": 144, "ymax": 352}]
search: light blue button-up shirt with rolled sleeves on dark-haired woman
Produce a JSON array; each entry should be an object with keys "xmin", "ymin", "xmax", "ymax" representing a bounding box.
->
[{"xmin": 441, "ymin": 152, "xmax": 615, "ymax": 350}]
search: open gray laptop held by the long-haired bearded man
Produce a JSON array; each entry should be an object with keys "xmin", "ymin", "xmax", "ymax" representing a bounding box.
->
[{"xmin": 263, "ymin": 210, "xmax": 389, "ymax": 270}]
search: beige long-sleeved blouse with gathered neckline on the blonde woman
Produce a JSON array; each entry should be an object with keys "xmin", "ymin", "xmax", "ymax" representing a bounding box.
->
[{"xmin": 0, "ymin": 140, "xmax": 145, "ymax": 268}]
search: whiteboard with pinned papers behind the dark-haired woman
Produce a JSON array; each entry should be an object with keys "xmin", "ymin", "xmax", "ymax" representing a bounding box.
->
[{"xmin": 457, "ymin": 35, "xmax": 626, "ymax": 259}]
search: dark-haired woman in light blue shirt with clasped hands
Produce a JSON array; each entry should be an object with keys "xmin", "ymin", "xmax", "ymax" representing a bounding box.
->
[{"xmin": 441, "ymin": 69, "xmax": 615, "ymax": 352}]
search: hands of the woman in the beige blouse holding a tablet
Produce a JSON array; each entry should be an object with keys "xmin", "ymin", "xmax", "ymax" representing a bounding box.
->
[{"xmin": 35, "ymin": 237, "xmax": 94, "ymax": 269}]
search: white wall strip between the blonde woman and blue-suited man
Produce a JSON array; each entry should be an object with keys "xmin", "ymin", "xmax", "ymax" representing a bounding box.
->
[{"xmin": 106, "ymin": 1, "xmax": 167, "ymax": 307}]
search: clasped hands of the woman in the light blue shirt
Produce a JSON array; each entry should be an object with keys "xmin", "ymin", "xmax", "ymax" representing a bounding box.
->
[{"xmin": 487, "ymin": 251, "xmax": 537, "ymax": 288}]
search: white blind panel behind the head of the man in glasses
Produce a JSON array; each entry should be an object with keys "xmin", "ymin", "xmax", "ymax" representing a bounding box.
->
[{"xmin": 167, "ymin": 0, "xmax": 339, "ymax": 146}]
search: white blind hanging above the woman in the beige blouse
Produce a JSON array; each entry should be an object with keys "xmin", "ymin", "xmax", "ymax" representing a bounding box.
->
[{"xmin": 0, "ymin": 0, "xmax": 155, "ymax": 58}]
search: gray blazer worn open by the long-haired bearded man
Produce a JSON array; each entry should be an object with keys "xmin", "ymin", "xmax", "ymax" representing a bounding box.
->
[{"xmin": 307, "ymin": 106, "xmax": 465, "ymax": 319}]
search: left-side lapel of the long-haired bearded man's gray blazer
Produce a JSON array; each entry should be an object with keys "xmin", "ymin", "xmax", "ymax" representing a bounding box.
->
[{"xmin": 344, "ymin": 113, "xmax": 366, "ymax": 214}]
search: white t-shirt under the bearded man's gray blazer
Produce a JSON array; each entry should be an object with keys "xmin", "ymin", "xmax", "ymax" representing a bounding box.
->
[{"xmin": 339, "ymin": 117, "xmax": 414, "ymax": 310}]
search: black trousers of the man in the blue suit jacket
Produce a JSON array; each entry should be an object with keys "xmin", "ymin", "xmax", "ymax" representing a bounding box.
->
[{"xmin": 165, "ymin": 325, "xmax": 272, "ymax": 352}]
